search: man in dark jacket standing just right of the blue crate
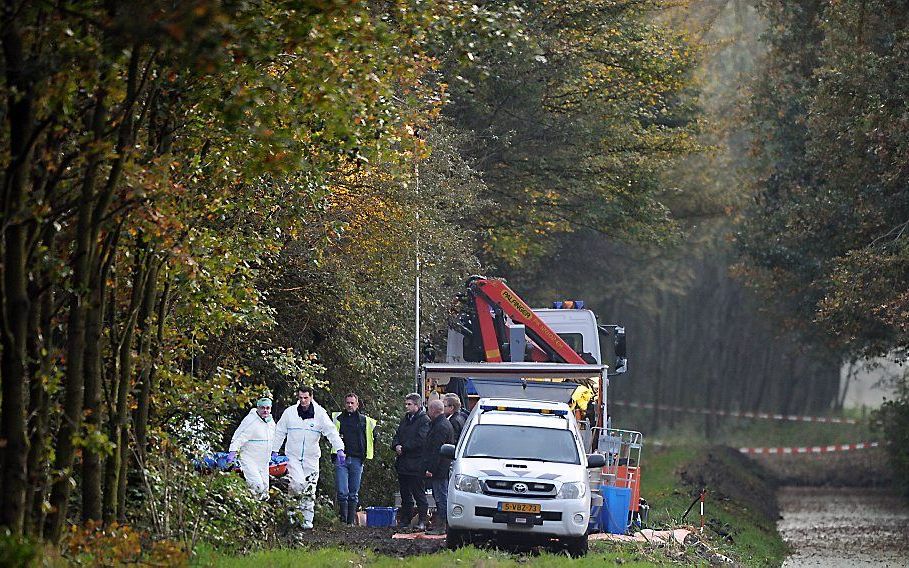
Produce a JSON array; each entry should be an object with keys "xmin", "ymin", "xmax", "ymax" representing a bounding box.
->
[{"xmin": 391, "ymin": 393, "xmax": 429, "ymax": 530}]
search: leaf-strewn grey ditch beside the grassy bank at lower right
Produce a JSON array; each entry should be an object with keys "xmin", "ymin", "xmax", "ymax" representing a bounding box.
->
[{"xmin": 777, "ymin": 487, "xmax": 909, "ymax": 568}]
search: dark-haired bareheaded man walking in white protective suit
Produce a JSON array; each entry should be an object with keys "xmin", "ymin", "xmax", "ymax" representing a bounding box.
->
[{"xmin": 272, "ymin": 386, "xmax": 345, "ymax": 529}]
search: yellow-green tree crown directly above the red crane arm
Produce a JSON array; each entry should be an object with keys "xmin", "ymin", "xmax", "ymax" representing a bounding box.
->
[{"xmin": 446, "ymin": 1, "xmax": 697, "ymax": 267}]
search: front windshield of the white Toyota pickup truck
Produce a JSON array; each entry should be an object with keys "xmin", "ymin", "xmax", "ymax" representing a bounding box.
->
[{"xmin": 462, "ymin": 424, "xmax": 581, "ymax": 464}]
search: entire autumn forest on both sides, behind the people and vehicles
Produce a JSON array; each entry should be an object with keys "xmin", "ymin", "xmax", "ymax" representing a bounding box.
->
[{"xmin": 0, "ymin": 0, "xmax": 909, "ymax": 556}]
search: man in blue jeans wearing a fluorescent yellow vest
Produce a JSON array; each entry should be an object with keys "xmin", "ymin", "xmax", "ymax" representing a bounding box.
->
[{"xmin": 331, "ymin": 393, "xmax": 376, "ymax": 525}]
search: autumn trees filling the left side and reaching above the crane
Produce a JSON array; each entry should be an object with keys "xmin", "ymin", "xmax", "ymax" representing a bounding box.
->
[{"xmin": 0, "ymin": 0, "xmax": 695, "ymax": 564}]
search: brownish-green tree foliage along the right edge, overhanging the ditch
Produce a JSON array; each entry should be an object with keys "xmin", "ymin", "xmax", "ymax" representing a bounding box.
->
[{"xmin": 741, "ymin": 0, "xmax": 909, "ymax": 488}]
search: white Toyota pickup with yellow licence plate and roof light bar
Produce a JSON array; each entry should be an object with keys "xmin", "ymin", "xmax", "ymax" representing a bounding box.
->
[{"xmin": 441, "ymin": 398, "xmax": 605, "ymax": 556}]
